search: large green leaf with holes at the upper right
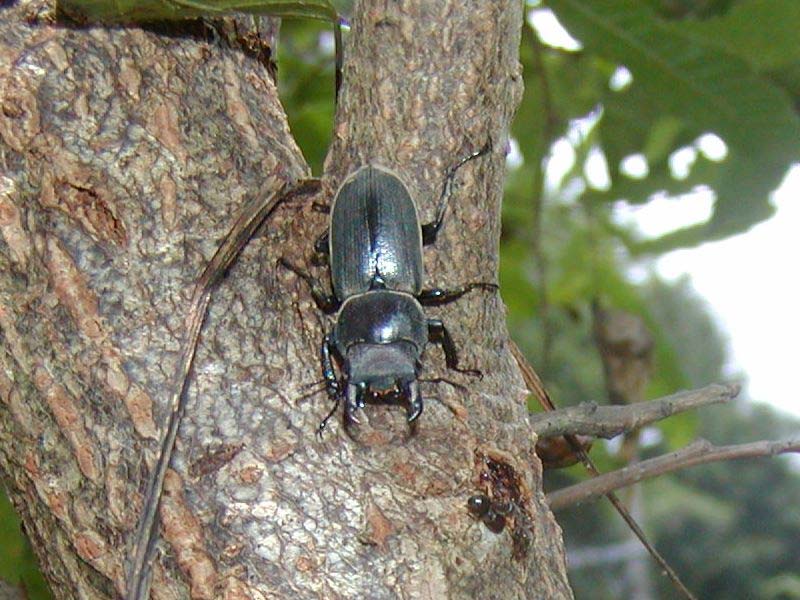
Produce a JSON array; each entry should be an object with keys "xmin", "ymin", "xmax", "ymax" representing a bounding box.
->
[{"xmin": 548, "ymin": 0, "xmax": 800, "ymax": 251}]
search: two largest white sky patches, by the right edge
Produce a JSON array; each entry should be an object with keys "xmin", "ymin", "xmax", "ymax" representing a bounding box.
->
[{"xmin": 620, "ymin": 171, "xmax": 800, "ymax": 416}]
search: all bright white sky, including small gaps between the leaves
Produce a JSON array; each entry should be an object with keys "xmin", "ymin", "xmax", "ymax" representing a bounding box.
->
[{"xmin": 528, "ymin": 0, "xmax": 800, "ymax": 416}]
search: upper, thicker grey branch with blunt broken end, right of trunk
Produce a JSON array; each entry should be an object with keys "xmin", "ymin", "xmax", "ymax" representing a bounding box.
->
[{"xmin": 530, "ymin": 384, "xmax": 739, "ymax": 439}]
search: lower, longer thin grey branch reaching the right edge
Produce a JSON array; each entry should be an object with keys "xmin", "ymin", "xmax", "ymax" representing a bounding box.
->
[{"xmin": 547, "ymin": 438, "xmax": 800, "ymax": 511}]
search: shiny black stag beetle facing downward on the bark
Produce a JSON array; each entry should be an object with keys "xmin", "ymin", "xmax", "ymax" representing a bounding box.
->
[{"xmin": 281, "ymin": 143, "xmax": 497, "ymax": 433}]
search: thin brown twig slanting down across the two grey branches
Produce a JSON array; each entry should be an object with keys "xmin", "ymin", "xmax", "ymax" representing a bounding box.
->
[{"xmin": 511, "ymin": 341, "xmax": 697, "ymax": 600}]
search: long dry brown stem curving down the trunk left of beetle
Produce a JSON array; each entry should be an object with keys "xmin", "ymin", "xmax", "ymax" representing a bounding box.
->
[{"xmin": 125, "ymin": 180, "xmax": 319, "ymax": 600}]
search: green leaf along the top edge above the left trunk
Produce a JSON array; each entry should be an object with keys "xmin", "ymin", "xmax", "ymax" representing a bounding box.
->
[{"xmin": 56, "ymin": 0, "xmax": 338, "ymax": 24}]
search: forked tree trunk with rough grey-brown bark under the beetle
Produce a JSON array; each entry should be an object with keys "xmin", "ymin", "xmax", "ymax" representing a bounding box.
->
[{"xmin": 0, "ymin": 0, "xmax": 571, "ymax": 599}]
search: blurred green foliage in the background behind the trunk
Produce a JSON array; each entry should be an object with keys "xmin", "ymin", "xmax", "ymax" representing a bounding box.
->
[{"xmin": 0, "ymin": 0, "xmax": 800, "ymax": 600}]
